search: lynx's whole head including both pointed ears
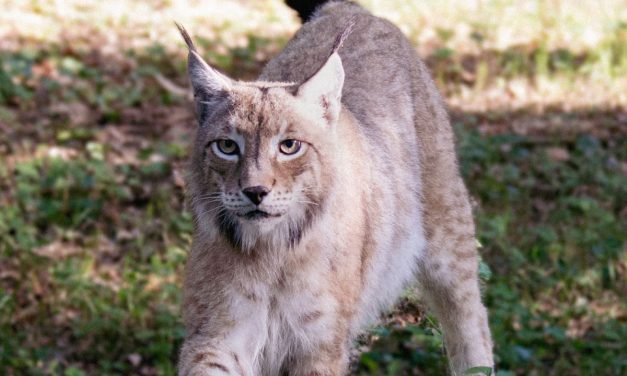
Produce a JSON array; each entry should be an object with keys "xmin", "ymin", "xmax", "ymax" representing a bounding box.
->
[{"xmin": 179, "ymin": 27, "xmax": 344, "ymax": 252}]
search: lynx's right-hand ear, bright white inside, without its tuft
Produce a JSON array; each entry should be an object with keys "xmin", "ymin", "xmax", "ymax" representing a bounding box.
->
[{"xmin": 296, "ymin": 52, "xmax": 344, "ymax": 124}]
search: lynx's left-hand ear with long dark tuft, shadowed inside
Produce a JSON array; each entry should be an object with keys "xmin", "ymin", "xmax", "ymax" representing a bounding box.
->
[{"xmin": 176, "ymin": 23, "xmax": 232, "ymax": 125}]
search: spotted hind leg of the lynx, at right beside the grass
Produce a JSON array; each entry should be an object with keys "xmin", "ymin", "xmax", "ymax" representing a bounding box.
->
[{"xmin": 419, "ymin": 182, "xmax": 493, "ymax": 375}]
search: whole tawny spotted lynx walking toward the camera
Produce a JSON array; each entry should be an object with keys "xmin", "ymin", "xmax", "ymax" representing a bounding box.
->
[{"xmin": 179, "ymin": 1, "xmax": 493, "ymax": 376}]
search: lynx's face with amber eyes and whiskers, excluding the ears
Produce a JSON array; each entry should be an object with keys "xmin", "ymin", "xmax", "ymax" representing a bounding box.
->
[{"xmin": 193, "ymin": 84, "xmax": 335, "ymax": 250}]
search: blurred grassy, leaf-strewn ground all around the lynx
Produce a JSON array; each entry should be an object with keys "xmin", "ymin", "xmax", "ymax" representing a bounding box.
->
[{"xmin": 0, "ymin": 0, "xmax": 627, "ymax": 376}]
